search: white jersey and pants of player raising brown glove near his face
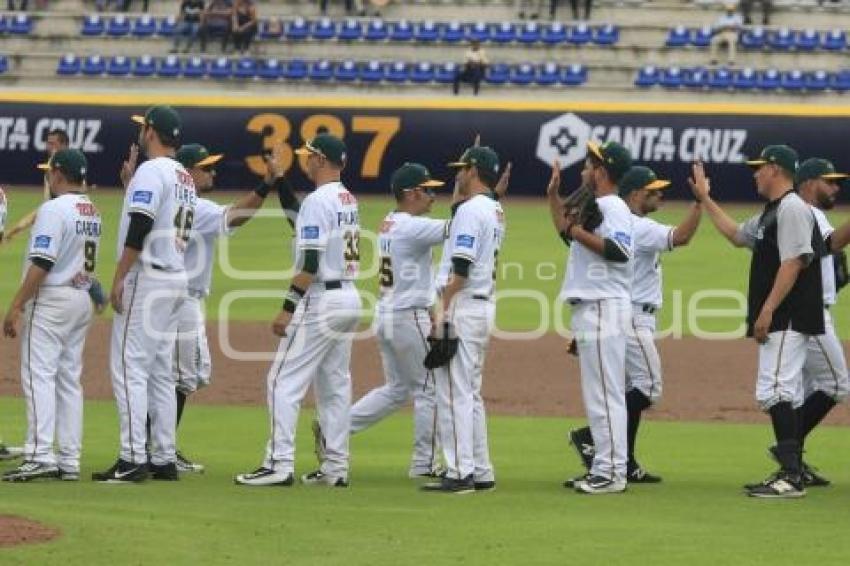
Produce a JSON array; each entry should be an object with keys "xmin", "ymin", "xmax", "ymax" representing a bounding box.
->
[{"xmin": 560, "ymin": 195, "xmax": 635, "ymax": 482}]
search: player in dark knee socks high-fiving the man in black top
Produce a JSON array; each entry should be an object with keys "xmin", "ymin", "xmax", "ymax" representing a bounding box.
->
[{"xmin": 565, "ymin": 166, "xmax": 702, "ymax": 487}]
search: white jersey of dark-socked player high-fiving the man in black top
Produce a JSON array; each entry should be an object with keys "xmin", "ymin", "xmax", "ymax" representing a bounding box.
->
[{"xmin": 632, "ymin": 214, "xmax": 675, "ymax": 307}]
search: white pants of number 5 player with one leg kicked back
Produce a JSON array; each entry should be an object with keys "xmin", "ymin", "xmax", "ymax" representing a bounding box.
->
[{"xmin": 351, "ymin": 309, "xmax": 437, "ymax": 475}]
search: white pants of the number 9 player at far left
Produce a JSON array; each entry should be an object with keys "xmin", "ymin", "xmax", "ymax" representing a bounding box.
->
[{"xmin": 21, "ymin": 287, "xmax": 92, "ymax": 472}]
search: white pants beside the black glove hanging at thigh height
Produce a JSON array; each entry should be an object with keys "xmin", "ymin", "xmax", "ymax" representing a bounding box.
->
[{"xmin": 434, "ymin": 296, "xmax": 496, "ymax": 482}]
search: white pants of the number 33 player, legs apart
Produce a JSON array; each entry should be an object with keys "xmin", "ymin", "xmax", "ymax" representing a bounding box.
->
[{"xmin": 263, "ymin": 288, "xmax": 361, "ymax": 478}]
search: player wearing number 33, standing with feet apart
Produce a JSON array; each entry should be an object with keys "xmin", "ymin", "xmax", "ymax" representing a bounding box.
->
[{"xmin": 234, "ymin": 134, "xmax": 361, "ymax": 487}]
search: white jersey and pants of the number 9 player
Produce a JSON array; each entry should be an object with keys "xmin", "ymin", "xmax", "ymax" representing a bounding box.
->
[{"xmin": 21, "ymin": 193, "xmax": 101, "ymax": 473}]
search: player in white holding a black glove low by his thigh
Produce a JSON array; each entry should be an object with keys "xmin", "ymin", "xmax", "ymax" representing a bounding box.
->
[{"xmin": 422, "ymin": 146, "xmax": 505, "ymax": 494}]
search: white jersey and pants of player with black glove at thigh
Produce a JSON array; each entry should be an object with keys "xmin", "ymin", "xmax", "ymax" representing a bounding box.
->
[{"xmin": 434, "ymin": 195, "xmax": 505, "ymax": 482}]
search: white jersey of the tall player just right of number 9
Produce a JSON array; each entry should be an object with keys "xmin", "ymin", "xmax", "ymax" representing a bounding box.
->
[{"xmin": 117, "ymin": 157, "xmax": 197, "ymax": 271}]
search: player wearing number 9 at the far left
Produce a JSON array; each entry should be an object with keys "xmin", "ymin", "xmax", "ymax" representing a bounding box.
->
[{"xmin": 3, "ymin": 149, "xmax": 101, "ymax": 481}]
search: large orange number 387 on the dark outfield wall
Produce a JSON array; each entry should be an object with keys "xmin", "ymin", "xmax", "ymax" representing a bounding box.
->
[{"xmin": 245, "ymin": 114, "xmax": 401, "ymax": 178}]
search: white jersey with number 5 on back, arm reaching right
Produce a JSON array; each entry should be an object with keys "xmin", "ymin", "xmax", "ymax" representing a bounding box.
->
[{"xmin": 378, "ymin": 212, "xmax": 448, "ymax": 311}]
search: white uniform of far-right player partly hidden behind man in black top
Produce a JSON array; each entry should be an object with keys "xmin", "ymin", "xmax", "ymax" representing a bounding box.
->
[{"xmin": 803, "ymin": 206, "xmax": 850, "ymax": 402}]
